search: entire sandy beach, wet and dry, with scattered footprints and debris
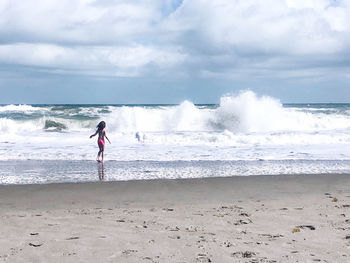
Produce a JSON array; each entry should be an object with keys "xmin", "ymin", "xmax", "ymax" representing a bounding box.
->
[{"xmin": 0, "ymin": 175, "xmax": 350, "ymax": 262}]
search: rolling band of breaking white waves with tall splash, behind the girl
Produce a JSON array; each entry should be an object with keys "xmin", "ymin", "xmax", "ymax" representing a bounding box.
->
[{"xmin": 0, "ymin": 91, "xmax": 350, "ymax": 136}]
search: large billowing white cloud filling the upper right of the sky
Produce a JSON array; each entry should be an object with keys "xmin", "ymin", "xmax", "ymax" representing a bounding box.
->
[{"xmin": 159, "ymin": 0, "xmax": 350, "ymax": 79}]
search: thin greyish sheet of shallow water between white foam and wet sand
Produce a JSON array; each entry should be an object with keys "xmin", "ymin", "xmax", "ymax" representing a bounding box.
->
[{"xmin": 0, "ymin": 160, "xmax": 350, "ymax": 184}]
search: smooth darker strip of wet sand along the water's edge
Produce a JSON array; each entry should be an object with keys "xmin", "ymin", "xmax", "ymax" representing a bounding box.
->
[{"xmin": 0, "ymin": 173, "xmax": 350, "ymax": 208}]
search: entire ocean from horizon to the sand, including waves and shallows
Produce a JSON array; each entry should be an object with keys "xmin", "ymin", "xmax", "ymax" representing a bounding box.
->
[{"xmin": 0, "ymin": 91, "xmax": 350, "ymax": 184}]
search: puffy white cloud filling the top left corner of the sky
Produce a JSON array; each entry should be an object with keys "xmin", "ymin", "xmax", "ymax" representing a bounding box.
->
[{"xmin": 0, "ymin": 0, "xmax": 160, "ymax": 44}]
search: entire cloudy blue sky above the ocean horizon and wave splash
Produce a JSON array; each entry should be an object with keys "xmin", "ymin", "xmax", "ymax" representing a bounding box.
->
[{"xmin": 0, "ymin": 0, "xmax": 350, "ymax": 104}]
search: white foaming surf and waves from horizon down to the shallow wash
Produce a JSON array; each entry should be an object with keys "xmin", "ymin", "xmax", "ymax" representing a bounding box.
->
[{"xmin": 0, "ymin": 91, "xmax": 350, "ymax": 169}]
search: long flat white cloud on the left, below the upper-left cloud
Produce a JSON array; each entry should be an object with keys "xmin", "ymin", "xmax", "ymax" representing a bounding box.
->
[{"xmin": 0, "ymin": 43, "xmax": 185, "ymax": 76}]
